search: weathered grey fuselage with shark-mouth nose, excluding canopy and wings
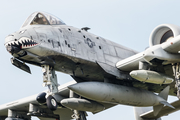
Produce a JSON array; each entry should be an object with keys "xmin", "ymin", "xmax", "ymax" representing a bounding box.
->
[{"xmin": 5, "ymin": 11, "xmax": 176, "ymax": 95}]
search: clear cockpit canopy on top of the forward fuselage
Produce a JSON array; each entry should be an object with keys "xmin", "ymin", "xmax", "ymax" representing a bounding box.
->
[{"xmin": 22, "ymin": 12, "xmax": 65, "ymax": 27}]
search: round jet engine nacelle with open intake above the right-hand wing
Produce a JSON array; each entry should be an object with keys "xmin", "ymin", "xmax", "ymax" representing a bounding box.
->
[{"xmin": 149, "ymin": 24, "xmax": 180, "ymax": 47}]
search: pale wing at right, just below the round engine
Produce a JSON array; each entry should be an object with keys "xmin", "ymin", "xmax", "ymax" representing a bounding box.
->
[{"xmin": 116, "ymin": 42, "xmax": 180, "ymax": 71}]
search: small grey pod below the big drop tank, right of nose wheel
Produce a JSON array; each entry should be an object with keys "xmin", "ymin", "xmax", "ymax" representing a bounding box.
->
[{"xmin": 61, "ymin": 98, "xmax": 105, "ymax": 112}]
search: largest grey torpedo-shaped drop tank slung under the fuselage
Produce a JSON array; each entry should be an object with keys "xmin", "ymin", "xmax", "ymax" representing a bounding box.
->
[{"xmin": 68, "ymin": 82, "xmax": 173, "ymax": 108}]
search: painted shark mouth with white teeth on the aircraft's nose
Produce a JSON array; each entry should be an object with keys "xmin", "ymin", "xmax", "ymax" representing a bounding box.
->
[{"xmin": 5, "ymin": 37, "xmax": 38, "ymax": 49}]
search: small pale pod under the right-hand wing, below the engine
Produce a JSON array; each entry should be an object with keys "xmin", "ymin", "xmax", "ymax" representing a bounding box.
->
[{"xmin": 130, "ymin": 70, "xmax": 174, "ymax": 84}]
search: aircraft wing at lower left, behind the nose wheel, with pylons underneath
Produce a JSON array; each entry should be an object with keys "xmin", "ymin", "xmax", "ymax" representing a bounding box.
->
[{"xmin": 0, "ymin": 81, "xmax": 115, "ymax": 120}]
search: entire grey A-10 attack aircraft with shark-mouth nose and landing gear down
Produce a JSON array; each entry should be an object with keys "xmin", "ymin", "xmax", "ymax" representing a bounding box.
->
[{"xmin": 0, "ymin": 12, "xmax": 180, "ymax": 120}]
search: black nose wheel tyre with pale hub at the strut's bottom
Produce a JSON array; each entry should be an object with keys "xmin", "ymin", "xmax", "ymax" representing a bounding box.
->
[{"xmin": 46, "ymin": 95, "xmax": 58, "ymax": 111}]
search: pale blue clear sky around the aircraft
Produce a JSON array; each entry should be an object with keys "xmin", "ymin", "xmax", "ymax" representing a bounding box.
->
[{"xmin": 0, "ymin": 0, "xmax": 180, "ymax": 120}]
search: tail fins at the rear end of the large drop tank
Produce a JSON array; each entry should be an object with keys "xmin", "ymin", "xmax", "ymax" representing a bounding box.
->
[{"xmin": 153, "ymin": 86, "xmax": 175, "ymax": 116}]
